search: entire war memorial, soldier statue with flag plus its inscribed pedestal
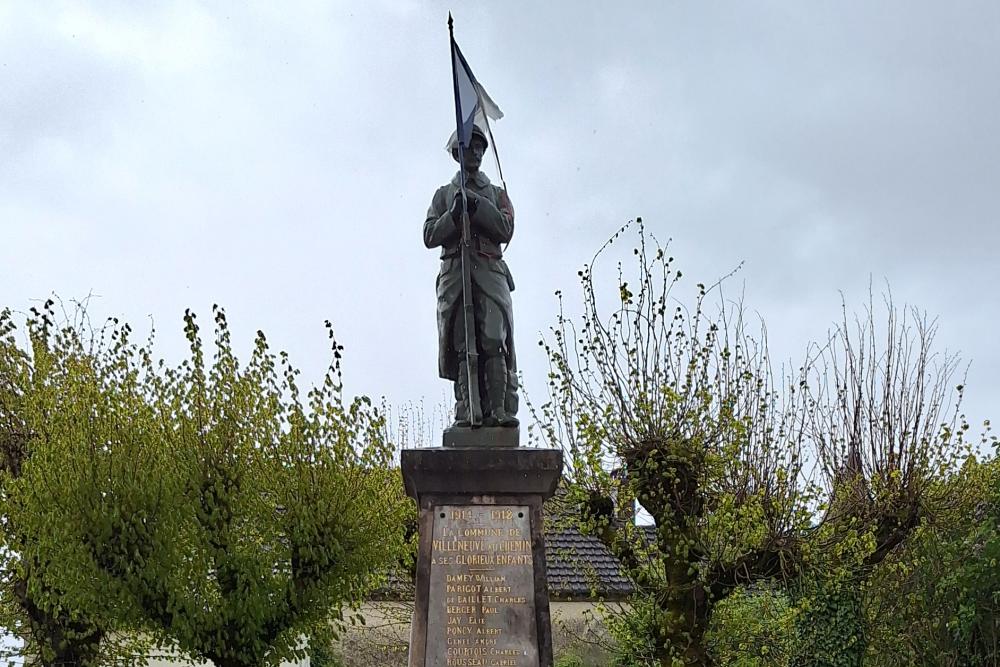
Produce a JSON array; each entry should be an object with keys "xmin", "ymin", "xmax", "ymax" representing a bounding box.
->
[{"xmin": 400, "ymin": 16, "xmax": 563, "ymax": 667}]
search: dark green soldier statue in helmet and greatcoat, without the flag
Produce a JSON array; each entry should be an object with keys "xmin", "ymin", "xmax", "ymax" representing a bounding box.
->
[{"xmin": 424, "ymin": 125, "xmax": 518, "ymax": 427}]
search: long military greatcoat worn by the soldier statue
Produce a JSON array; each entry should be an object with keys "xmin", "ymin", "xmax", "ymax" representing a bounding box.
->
[{"xmin": 424, "ymin": 172, "xmax": 517, "ymax": 386}]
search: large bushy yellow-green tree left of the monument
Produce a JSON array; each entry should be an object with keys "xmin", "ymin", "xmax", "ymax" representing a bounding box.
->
[{"xmin": 6, "ymin": 309, "xmax": 406, "ymax": 667}]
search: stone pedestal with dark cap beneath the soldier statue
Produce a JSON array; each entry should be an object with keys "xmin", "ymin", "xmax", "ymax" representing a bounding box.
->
[{"xmin": 402, "ymin": 447, "xmax": 562, "ymax": 667}]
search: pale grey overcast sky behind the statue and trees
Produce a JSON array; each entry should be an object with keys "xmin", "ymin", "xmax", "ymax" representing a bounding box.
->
[{"xmin": 0, "ymin": 0, "xmax": 1000, "ymax": 446}]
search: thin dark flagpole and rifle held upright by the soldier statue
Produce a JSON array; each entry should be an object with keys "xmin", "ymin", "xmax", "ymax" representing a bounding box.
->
[{"xmin": 448, "ymin": 12, "xmax": 483, "ymax": 428}]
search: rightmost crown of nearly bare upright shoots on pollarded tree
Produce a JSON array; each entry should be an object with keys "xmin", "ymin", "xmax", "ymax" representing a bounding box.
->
[{"xmin": 803, "ymin": 293, "xmax": 971, "ymax": 565}]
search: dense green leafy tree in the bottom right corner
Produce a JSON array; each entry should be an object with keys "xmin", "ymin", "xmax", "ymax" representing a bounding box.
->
[{"xmin": 865, "ymin": 456, "xmax": 1000, "ymax": 667}]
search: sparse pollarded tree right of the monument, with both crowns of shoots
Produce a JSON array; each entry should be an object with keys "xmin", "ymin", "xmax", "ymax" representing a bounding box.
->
[{"xmin": 536, "ymin": 220, "xmax": 961, "ymax": 665}]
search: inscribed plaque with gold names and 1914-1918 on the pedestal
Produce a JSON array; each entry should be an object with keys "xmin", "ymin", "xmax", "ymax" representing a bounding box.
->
[{"xmin": 425, "ymin": 505, "xmax": 538, "ymax": 667}]
